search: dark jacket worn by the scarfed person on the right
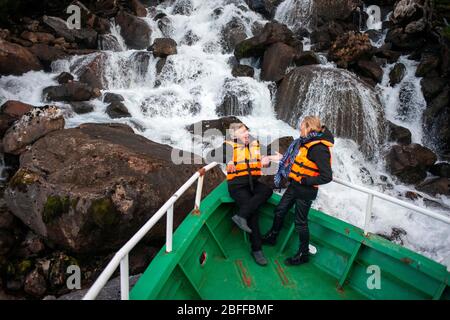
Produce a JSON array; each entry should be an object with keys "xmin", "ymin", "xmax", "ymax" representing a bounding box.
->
[{"xmin": 290, "ymin": 128, "xmax": 334, "ymax": 200}]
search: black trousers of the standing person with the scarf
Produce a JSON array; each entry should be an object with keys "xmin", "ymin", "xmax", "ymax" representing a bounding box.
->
[{"xmin": 272, "ymin": 182, "xmax": 317, "ymax": 254}]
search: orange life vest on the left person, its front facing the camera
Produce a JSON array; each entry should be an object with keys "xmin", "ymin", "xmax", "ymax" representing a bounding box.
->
[{"xmin": 225, "ymin": 140, "xmax": 262, "ymax": 180}]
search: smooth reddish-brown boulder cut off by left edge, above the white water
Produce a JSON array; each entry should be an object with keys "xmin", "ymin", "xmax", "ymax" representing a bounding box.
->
[{"xmin": 0, "ymin": 39, "xmax": 43, "ymax": 75}]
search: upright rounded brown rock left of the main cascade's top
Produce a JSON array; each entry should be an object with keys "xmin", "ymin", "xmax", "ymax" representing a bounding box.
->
[{"xmin": 115, "ymin": 11, "xmax": 152, "ymax": 50}]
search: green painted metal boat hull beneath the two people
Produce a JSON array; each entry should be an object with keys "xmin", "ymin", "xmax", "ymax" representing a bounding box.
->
[{"xmin": 130, "ymin": 182, "xmax": 450, "ymax": 300}]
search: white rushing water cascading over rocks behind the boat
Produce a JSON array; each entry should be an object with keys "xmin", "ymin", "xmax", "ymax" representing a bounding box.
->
[{"xmin": 0, "ymin": 0, "xmax": 450, "ymax": 262}]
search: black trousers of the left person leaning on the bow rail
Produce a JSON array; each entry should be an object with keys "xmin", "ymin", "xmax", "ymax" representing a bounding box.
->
[{"xmin": 228, "ymin": 181, "xmax": 273, "ymax": 251}]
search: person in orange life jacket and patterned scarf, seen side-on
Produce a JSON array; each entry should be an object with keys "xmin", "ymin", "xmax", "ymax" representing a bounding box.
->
[{"xmin": 262, "ymin": 116, "xmax": 334, "ymax": 265}]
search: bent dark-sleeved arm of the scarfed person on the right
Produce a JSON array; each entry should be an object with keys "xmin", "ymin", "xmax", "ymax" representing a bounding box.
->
[{"xmin": 301, "ymin": 144, "xmax": 333, "ymax": 186}]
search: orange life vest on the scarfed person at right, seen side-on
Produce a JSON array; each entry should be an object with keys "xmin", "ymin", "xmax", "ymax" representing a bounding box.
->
[{"xmin": 289, "ymin": 140, "xmax": 333, "ymax": 188}]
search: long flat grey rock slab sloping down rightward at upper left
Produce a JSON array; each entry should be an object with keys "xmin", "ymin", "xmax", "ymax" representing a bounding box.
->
[{"xmin": 42, "ymin": 16, "xmax": 98, "ymax": 49}]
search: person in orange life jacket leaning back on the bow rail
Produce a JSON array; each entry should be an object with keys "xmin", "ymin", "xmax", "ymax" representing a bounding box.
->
[{"xmin": 207, "ymin": 123, "xmax": 272, "ymax": 265}]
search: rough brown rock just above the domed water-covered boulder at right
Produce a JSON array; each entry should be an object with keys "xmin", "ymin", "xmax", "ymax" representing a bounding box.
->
[{"xmin": 328, "ymin": 32, "xmax": 373, "ymax": 67}]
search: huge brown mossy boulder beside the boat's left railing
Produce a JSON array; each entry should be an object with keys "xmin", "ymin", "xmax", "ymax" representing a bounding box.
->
[{"xmin": 5, "ymin": 124, "xmax": 224, "ymax": 253}]
